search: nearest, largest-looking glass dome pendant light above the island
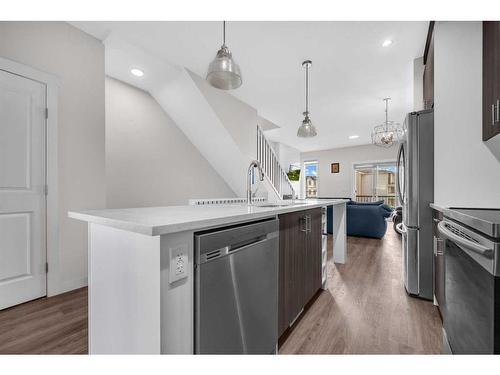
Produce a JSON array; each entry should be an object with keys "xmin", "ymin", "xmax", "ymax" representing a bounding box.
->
[{"xmin": 207, "ymin": 21, "xmax": 242, "ymax": 90}]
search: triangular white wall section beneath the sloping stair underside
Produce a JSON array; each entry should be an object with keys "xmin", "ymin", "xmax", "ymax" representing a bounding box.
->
[{"xmin": 106, "ymin": 77, "xmax": 234, "ymax": 208}]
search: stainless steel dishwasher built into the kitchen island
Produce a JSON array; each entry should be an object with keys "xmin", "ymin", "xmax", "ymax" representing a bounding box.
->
[{"xmin": 195, "ymin": 219, "xmax": 279, "ymax": 354}]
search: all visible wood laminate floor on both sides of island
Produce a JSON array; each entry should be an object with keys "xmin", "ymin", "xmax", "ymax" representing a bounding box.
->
[{"xmin": 0, "ymin": 228, "xmax": 441, "ymax": 354}]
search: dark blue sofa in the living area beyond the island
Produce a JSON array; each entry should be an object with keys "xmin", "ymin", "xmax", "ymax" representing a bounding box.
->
[{"xmin": 327, "ymin": 200, "xmax": 392, "ymax": 238}]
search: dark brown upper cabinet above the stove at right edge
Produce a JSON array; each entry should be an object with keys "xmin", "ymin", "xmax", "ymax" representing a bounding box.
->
[{"xmin": 483, "ymin": 21, "xmax": 500, "ymax": 141}]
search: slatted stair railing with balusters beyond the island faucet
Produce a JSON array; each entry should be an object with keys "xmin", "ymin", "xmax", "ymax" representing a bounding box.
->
[{"xmin": 257, "ymin": 125, "xmax": 296, "ymax": 199}]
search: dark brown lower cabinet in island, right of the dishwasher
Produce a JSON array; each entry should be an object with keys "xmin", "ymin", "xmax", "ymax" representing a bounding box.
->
[{"xmin": 278, "ymin": 208, "xmax": 322, "ymax": 336}]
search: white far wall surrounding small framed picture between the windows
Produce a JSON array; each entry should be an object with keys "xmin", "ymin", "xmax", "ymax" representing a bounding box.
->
[{"xmin": 300, "ymin": 145, "xmax": 397, "ymax": 198}]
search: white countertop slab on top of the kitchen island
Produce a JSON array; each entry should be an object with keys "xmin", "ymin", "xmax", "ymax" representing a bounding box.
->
[{"xmin": 68, "ymin": 199, "xmax": 348, "ymax": 236}]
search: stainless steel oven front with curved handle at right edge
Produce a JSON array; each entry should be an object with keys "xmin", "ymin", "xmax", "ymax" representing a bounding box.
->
[{"xmin": 437, "ymin": 217, "xmax": 500, "ymax": 354}]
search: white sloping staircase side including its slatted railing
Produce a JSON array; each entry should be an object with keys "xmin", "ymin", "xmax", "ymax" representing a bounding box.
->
[{"xmin": 105, "ymin": 33, "xmax": 296, "ymax": 201}]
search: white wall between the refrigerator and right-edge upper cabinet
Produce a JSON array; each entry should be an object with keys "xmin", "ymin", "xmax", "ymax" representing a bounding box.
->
[{"xmin": 434, "ymin": 22, "xmax": 500, "ymax": 207}]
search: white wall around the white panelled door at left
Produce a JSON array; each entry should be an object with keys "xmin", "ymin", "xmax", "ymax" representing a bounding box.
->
[{"xmin": 0, "ymin": 22, "xmax": 105, "ymax": 294}]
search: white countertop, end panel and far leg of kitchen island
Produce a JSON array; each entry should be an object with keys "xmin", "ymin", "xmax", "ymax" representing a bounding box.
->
[{"xmin": 69, "ymin": 199, "xmax": 347, "ymax": 354}]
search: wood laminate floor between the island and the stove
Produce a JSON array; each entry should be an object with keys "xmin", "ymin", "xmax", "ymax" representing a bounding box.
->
[{"xmin": 279, "ymin": 227, "xmax": 441, "ymax": 354}]
